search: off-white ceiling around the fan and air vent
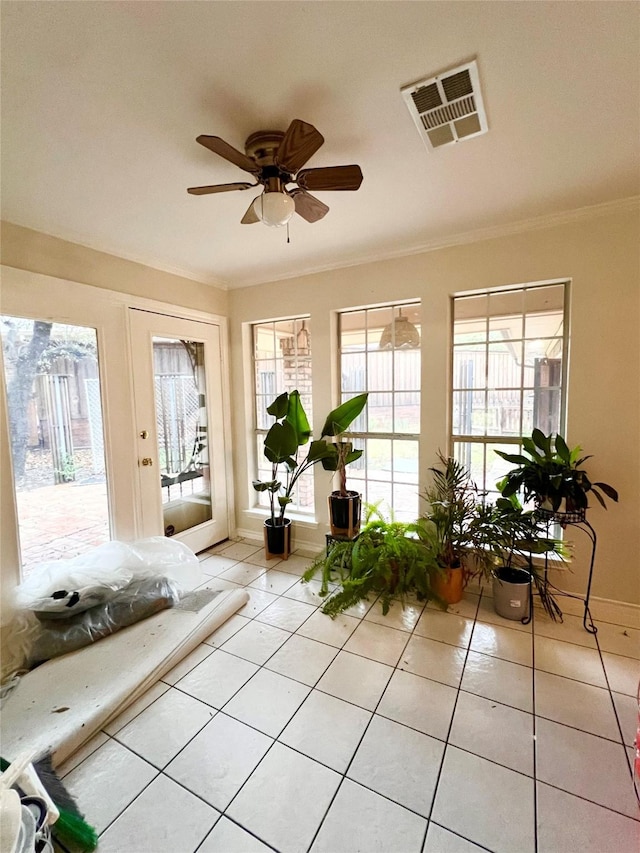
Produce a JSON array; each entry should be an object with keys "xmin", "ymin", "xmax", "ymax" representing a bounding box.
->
[{"xmin": 1, "ymin": 0, "xmax": 640, "ymax": 287}]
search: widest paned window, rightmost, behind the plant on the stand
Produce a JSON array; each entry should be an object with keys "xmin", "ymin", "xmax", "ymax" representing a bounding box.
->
[{"xmin": 451, "ymin": 283, "xmax": 569, "ymax": 498}]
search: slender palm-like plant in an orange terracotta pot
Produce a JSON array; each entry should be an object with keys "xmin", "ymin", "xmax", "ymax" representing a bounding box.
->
[{"xmin": 421, "ymin": 452, "xmax": 478, "ymax": 604}]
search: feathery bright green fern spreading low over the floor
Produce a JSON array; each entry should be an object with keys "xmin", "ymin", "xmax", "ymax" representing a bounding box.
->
[{"xmin": 302, "ymin": 505, "xmax": 441, "ymax": 618}]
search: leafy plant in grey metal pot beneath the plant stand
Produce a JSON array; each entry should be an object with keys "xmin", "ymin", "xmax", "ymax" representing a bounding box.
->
[{"xmin": 476, "ymin": 495, "xmax": 569, "ymax": 621}]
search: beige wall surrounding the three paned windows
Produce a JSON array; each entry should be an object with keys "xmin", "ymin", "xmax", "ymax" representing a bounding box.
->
[{"xmin": 229, "ymin": 206, "xmax": 640, "ymax": 603}]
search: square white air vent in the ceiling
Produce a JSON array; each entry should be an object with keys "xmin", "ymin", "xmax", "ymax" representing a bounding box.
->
[{"xmin": 400, "ymin": 60, "xmax": 487, "ymax": 148}]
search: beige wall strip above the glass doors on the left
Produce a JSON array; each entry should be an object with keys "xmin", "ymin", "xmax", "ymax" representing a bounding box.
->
[{"xmin": 0, "ymin": 222, "xmax": 228, "ymax": 316}]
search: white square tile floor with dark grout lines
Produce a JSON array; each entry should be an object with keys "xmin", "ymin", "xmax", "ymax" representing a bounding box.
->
[{"xmin": 60, "ymin": 541, "xmax": 640, "ymax": 853}]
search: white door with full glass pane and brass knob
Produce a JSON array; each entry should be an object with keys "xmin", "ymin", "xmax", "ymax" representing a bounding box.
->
[{"xmin": 129, "ymin": 308, "xmax": 229, "ymax": 552}]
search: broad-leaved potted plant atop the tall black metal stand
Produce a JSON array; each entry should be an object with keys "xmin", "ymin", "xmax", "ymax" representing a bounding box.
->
[{"xmin": 495, "ymin": 429, "xmax": 618, "ymax": 518}]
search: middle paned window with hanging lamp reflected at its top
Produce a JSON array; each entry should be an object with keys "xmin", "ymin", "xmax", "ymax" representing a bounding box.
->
[{"xmin": 339, "ymin": 302, "xmax": 421, "ymax": 521}]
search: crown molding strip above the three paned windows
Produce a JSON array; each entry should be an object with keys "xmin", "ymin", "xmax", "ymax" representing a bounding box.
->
[{"xmin": 230, "ymin": 195, "xmax": 640, "ymax": 290}]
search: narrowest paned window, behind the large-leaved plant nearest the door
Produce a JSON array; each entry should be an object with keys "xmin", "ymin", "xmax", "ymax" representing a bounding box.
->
[{"xmin": 253, "ymin": 317, "xmax": 314, "ymax": 513}]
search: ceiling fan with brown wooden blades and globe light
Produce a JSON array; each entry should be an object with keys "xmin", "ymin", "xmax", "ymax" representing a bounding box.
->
[{"xmin": 187, "ymin": 119, "xmax": 362, "ymax": 226}]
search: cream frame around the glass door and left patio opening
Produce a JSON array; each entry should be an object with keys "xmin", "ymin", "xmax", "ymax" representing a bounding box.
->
[{"xmin": 0, "ymin": 265, "xmax": 235, "ymax": 599}]
